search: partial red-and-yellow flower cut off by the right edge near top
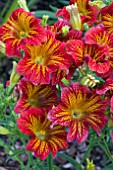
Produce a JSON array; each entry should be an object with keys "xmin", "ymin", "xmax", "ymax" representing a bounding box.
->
[{"xmin": 100, "ymin": 2, "xmax": 113, "ymax": 34}]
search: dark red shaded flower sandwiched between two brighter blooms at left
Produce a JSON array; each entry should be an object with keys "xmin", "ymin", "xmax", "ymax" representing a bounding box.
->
[{"xmin": 14, "ymin": 78, "xmax": 59, "ymax": 113}]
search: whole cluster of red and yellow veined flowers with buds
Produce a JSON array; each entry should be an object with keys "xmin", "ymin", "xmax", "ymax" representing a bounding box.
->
[{"xmin": 0, "ymin": 0, "xmax": 113, "ymax": 160}]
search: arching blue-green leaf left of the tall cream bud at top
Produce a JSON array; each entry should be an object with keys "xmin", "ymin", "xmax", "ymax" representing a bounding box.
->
[{"xmin": 34, "ymin": 10, "xmax": 57, "ymax": 19}]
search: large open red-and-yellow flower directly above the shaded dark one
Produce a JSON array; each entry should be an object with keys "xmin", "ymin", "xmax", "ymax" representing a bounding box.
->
[{"xmin": 17, "ymin": 31, "xmax": 71, "ymax": 85}]
